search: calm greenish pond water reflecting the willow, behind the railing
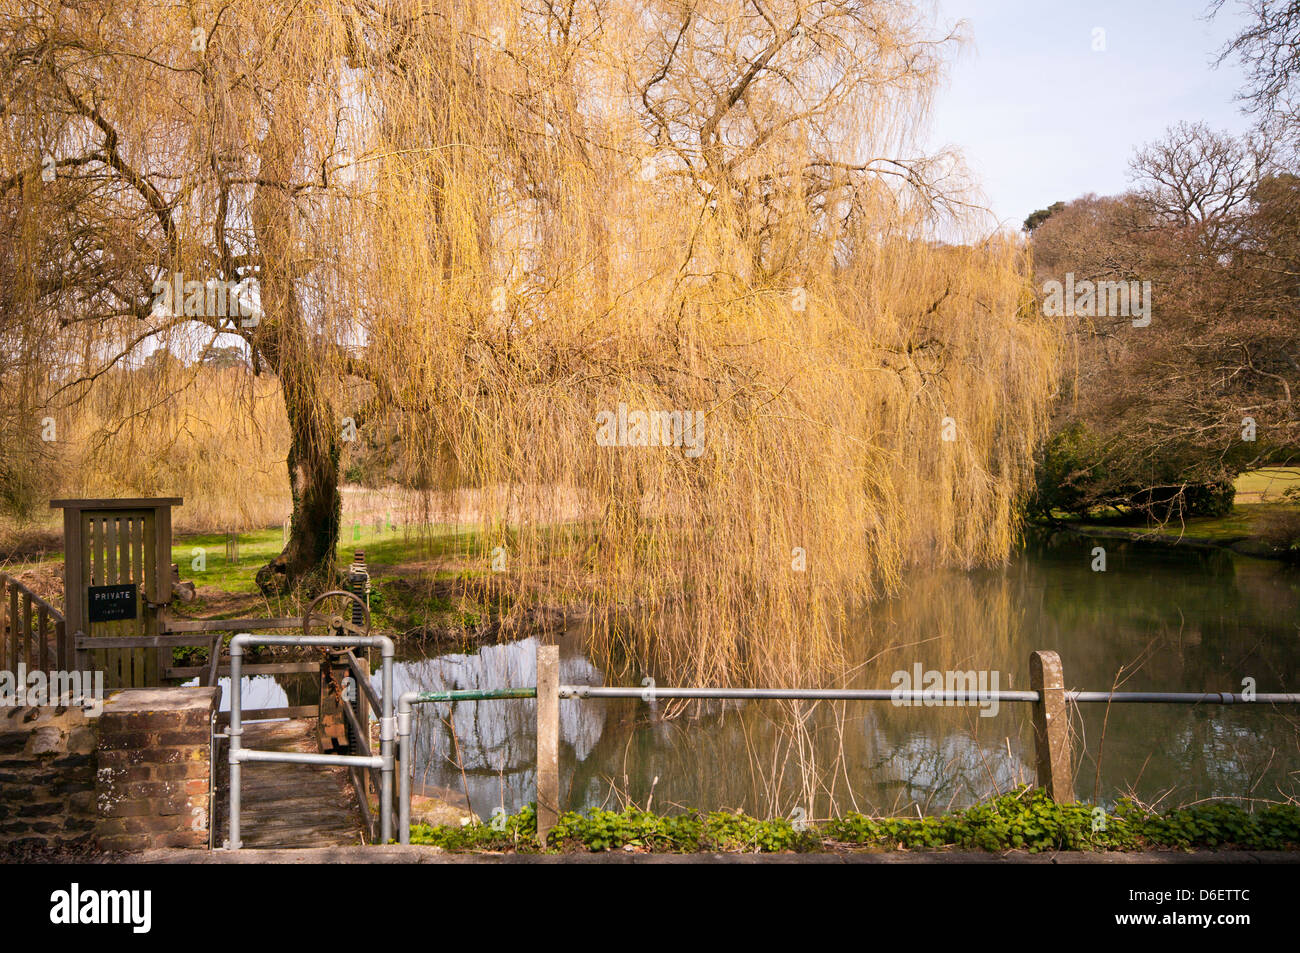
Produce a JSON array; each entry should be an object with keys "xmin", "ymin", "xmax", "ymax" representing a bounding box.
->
[{"xmin": 250, "ymin": 536, "xmax": 1300, "ymax": 816}]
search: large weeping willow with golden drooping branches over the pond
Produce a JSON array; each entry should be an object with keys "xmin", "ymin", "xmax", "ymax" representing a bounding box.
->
[{"xmin": 0, "ymin": 0, "xmax": 1057, "ymax": 680}]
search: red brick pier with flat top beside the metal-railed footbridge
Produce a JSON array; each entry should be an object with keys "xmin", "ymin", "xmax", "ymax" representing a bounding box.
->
[{"xmin": 95, "ymin": 688, "xmax": 221, "ymax": 850}]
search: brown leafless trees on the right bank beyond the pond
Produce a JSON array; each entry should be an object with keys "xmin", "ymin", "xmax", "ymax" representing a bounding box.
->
[{"xmin": 1032, "ymin": 124, "xmax": 1300, "ymax": 517}]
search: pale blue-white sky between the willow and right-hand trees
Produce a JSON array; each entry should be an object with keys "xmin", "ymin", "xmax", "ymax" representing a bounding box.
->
[{"xmin": 930, "ymin": 0, "xmax": 1251, "ymax": 228}]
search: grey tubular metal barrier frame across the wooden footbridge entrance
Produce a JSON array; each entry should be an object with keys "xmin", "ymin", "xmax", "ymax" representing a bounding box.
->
[{"xmin": 226, "ymin": 632, "xmax": 395, "ymax": 850}]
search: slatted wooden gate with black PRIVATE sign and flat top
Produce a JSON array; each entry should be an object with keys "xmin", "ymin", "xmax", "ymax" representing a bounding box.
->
[{"xmin": 49, "ymin": 497, "xmax": 182, "ymax": 688}]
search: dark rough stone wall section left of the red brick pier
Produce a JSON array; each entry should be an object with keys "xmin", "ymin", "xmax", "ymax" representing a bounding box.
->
[{"xmin": 0, "ymin": 707, "xmax": 96, "ymax": 848}]
